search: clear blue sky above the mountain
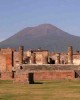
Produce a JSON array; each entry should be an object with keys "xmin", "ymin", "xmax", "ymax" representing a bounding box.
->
[{"xmin": 0, "ymin": 0, "xmax": 80, "ymax": 41}]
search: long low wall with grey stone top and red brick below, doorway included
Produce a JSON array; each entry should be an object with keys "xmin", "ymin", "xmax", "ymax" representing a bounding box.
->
[{"xmin": 14, "ymin": 65, "xmax": 80, "ymax": 83}]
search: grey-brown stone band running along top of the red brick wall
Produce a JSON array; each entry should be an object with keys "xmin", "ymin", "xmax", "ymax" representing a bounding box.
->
[{"xmin": 19, "ymin": 64, "xmax": 80, "ymax": 71}]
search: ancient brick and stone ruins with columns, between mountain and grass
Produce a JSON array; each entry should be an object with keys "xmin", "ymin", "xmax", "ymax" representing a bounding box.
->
[{"xmin": 0, "ymin": 46, "xmax": 80, "ymax": 83}]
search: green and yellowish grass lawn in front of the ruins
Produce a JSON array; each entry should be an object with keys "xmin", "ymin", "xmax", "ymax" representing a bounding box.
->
[{"xmin": 0, "ymin": 80, "xmax": 80, "ymax": 100}]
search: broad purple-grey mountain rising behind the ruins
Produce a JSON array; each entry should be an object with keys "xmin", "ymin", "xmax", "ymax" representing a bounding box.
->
[{"xmin": 0, "ymin": 24, "xmax": 80, "ymax": 52}]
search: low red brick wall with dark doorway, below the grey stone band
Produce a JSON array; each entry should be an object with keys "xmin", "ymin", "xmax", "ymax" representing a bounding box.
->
[{"xmin": 14, "ymin": 70, "xmax": 75, "ymax": 83}]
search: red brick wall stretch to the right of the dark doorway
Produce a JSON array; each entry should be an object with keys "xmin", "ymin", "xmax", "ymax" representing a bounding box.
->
[{"xmin": 34, "ymin": 70, "xmax": 74, "ymax": 81}]
